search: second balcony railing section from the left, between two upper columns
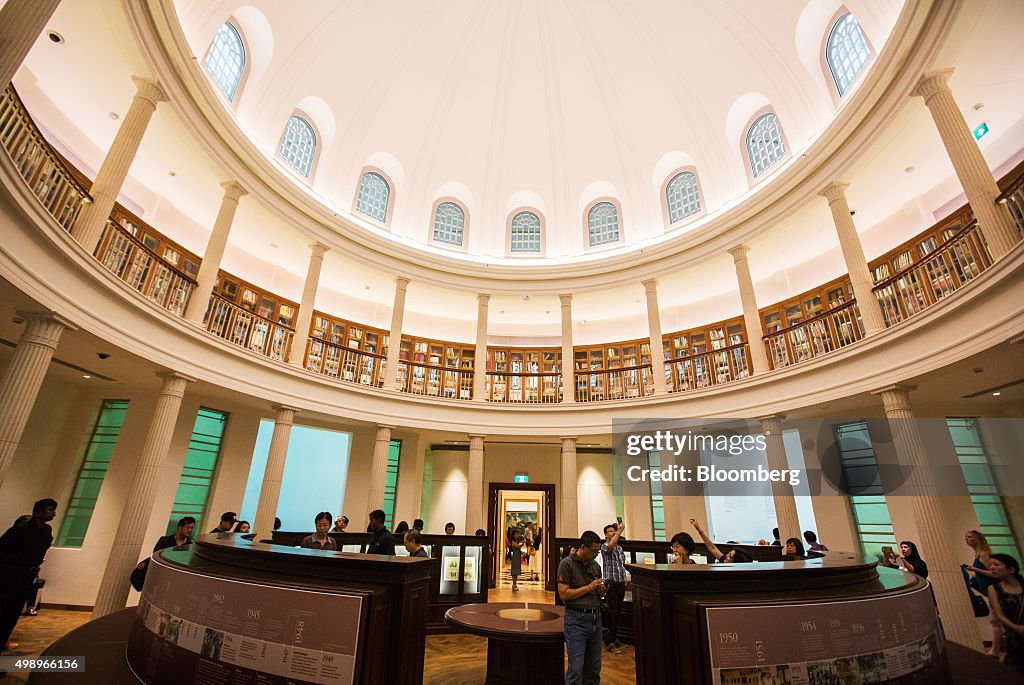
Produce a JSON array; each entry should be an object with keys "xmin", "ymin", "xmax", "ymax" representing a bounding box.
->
[{"xmin": 96, "ymin": 220, "xmax": 196, "ymax": 316}]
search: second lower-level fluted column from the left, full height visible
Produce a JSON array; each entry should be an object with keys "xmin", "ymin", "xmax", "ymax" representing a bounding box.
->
[{"xmin": 92, "ymin": 372, "xmax": 195, "ymax": 618}]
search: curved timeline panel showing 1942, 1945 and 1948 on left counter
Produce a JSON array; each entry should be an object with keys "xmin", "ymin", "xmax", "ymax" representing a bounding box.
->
[{"xmin": 127, "ymin": 560, "xmax": 365, "ymax": 685}]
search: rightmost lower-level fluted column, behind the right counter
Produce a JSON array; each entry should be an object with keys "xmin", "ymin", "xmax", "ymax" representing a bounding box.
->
[{"xmin": 872, "ymin": 385, "xmax": 981, "ymax": 649}]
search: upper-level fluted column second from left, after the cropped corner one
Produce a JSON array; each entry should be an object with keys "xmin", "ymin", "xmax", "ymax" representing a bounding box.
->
[{"xmin": 71, "ymin": 76, "xmax": 167, "ymax": 253}]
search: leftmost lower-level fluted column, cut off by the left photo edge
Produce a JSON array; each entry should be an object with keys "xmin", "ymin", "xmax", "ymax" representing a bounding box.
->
[{"xmin": 0, "ymin": 309, "xmax": 75, "ymax": 484}]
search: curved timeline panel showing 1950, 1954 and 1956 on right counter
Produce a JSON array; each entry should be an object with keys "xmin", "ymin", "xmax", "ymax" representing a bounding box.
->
[{"xmin": 707, "ymin": 587, "xmax": 944, "ymax": 685}]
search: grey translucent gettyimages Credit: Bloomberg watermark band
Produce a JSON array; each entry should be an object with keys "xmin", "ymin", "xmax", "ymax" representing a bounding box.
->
[{"xmin": 612, "ymin": 418, "xmax": 1024, "ymax": 497}]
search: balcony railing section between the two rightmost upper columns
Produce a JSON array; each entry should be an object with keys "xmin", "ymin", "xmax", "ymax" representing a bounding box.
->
[{"xmin": 872, "ymin": 221, "xmax": 992, "ymax": 326}]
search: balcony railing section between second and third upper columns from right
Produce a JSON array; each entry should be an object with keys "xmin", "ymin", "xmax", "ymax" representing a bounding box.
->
[{"xmin": 764, "ymin": 300, "xmax": 864, "ymax": 369}]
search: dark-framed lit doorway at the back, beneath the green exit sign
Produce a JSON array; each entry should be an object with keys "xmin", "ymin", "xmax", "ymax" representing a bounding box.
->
[{"xmin": 487, "ymin": 483, "xmax": 556, "ymax": 590}]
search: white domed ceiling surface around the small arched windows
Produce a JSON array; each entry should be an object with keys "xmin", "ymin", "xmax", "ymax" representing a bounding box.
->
[{"xmin": 174, "ymin": 0, "xmax": 902, "ymax": 261}]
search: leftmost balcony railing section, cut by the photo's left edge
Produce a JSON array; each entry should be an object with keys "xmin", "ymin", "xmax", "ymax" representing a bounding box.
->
[{"xmin": 0, "ymin": 86, "xmax": 92, "ymax": 230}]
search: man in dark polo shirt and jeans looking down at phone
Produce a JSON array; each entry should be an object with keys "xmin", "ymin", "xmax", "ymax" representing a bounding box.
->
[{"xmin": 558, "ymin": 530, "xmax": 604, "ymax": 685}]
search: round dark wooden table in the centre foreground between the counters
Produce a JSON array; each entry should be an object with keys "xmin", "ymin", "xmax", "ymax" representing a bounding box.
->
[{"xmin": 444, "ymin": 602, "xmax": 565, "ymax": 685}]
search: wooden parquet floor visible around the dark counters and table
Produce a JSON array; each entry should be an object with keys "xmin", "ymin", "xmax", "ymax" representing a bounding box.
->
[{"xmin": 0, "ymin": 584, "xmax": 636, "ymax": 685}]
